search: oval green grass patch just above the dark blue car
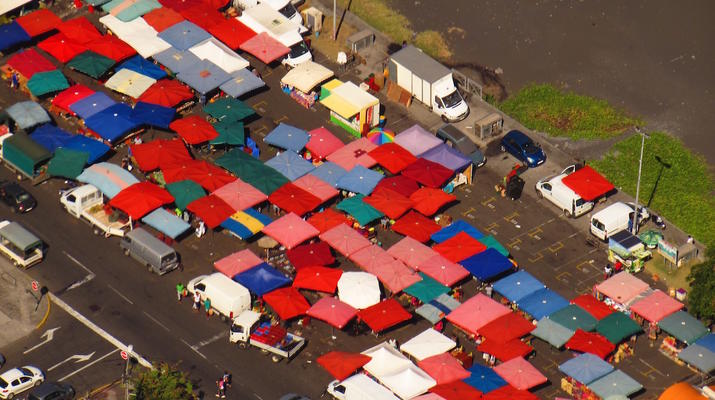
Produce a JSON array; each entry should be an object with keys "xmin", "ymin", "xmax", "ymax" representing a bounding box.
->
[{"xmin": 500, "ymin": 84, "xmax": 642, "ymax": 140}]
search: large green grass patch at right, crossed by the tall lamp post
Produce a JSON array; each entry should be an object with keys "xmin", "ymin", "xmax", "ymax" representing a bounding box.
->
[{"xmin": 591, "ymin": 132, "xmax": 715, "ymax": 246}]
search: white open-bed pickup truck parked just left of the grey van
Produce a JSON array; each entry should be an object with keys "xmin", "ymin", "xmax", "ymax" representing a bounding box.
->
[{"xmin": 60, "ymin": 185, "xmax": 129, "ymax": 237}]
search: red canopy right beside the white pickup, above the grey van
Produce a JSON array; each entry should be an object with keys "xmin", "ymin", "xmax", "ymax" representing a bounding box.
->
[{"xmin": 109, "ymin": 181, "xmax": 174, "ymax": 219}]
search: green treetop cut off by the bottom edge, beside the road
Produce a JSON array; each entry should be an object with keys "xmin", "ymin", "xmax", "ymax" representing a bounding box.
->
[{"xmin": 132, "ymin": 363, "xmax": 197, "ymax": 400}]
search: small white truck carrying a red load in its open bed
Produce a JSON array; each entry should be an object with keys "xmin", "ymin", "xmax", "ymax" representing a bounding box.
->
[{"xmin": 228, "ymin": 310, "xmax": 305, "ymax": 362}]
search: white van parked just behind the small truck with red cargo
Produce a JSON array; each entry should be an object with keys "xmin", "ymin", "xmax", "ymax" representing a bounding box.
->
[{"xmin": 186, "ymin": 272, "xmax": 251, "ymax": 320}]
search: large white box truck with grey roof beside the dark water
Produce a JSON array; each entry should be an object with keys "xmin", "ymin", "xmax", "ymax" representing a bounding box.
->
[{"xmin": 387, "ymin": 46, "xmax": 469, "ymax": 122}]
